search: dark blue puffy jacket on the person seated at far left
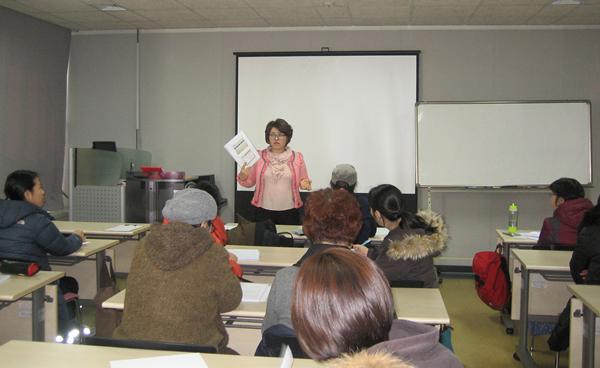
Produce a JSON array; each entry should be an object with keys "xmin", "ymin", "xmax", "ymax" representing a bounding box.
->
[{"xmin": 0, "ymin": 200, "xmax": 81, "ymax": 271}]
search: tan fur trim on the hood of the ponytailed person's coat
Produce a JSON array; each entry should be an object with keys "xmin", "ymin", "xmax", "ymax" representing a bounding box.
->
[{"xmin": 387, "ymin": 210, "xmax": 448, "ymax": 261}]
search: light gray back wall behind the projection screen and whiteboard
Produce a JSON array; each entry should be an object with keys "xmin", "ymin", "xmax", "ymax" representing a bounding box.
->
[{"xmin": 69, "ymin": 29, "xmax": 600, "ymax": 264}]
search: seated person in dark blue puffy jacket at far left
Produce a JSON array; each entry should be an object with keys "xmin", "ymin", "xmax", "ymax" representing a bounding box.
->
[{"xmin": 0, "ymin": 170, "xmax": 85, "ymax": 333}]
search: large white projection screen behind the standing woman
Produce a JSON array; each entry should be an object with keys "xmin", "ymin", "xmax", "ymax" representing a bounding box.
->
[{"xmin": 236, "ymin": 52, "xmax": 418, "ymax": 194}]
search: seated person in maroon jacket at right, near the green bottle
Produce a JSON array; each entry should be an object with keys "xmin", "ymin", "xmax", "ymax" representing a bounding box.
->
[{"xmin": 534, "ymin": 178, "xmax": 594, "ymax": 249}]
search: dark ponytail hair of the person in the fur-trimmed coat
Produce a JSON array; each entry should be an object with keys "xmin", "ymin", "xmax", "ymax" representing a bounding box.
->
[{"xmin": 369, "ymin": 184, "xmax": 435, "ymax": 233}]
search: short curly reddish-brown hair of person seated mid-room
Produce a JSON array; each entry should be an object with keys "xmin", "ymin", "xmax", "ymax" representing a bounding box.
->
[{"xmin": 302, "ymin": 188, "xmax": 362, "ymax": 244}]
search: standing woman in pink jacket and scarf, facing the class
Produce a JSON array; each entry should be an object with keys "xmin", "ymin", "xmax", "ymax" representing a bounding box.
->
[{"xmin": 237, "ymin": 119, "xmax": 311, "ymax": 225}]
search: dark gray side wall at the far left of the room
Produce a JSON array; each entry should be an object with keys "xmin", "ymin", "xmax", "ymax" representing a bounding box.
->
[{"xmin": 0, "ymin": 6, "xmax": 71, "ymax": 209}]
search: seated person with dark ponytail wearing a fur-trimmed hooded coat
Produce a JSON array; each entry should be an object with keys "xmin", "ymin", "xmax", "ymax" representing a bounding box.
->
[{"xmin": 354, "ymin": 184, "xmax": 448, "ymax": 288}]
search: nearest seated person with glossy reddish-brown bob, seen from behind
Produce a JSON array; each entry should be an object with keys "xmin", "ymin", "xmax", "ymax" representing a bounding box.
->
[{"xmin": 292, "ymin": 248, "xmax": 462, "ymax": 368}]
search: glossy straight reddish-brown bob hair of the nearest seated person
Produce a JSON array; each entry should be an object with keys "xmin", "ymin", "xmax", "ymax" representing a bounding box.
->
[{"xmin": 292, "ymin": 247, "xmax": 394, "ymax": 360}]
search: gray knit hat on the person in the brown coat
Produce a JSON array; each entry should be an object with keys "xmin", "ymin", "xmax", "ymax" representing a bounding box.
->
[{"xmin": 162, "ymin": 188, "xmax": 217, "ymax": 225}]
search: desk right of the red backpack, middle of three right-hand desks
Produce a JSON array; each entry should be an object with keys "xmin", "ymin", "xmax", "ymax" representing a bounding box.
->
[{"xmin": 512, "ymin": 249, "xmax": 573, "ymax": 367}]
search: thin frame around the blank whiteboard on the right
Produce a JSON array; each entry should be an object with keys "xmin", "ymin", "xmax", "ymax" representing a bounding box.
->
[{"xmin": 415, "ymin": 99, "xmax": 593, "ymax": 189}]
